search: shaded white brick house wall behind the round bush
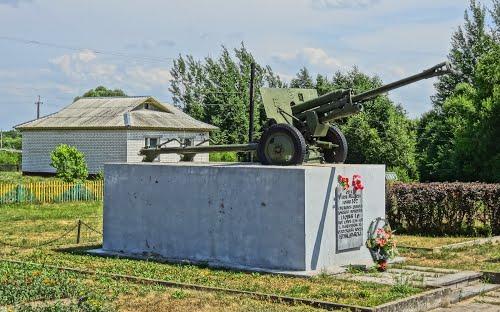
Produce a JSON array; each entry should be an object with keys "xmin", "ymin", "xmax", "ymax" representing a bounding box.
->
[{"xmin": 23, "ymin": 130, "xmax": 127, "ymax": 174}]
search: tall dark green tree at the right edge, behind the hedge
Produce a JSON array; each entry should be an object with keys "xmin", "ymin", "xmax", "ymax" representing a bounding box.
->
[{"xmin": 417, "ymin": 0, "xmax": 500, "ymax": 181}]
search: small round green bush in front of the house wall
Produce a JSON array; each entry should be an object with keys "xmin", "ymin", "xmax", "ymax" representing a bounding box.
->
[{"xmin": 50, "ymin": 144, "xmax": 88, "ymax": 182}]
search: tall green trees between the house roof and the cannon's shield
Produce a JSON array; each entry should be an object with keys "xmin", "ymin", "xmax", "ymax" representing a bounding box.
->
[{"xmin": 169, "ymin": 43, "xmax": 285, "ymax": 144}]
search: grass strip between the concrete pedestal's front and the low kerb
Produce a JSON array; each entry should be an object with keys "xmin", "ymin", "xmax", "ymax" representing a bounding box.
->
[{"xmin": 6, "ymin": 246, "xmax": 423, "ymax": 306}]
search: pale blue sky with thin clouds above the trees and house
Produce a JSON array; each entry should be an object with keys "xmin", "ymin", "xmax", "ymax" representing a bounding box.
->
[{"xmin": 0, "ymin": 0, "xmax": 480, "ymax": 130}]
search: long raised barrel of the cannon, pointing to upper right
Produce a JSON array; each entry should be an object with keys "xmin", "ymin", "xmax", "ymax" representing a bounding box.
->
[{"xmin": 352, "ymin": 62, "xmax": 451, "ymax": 103}]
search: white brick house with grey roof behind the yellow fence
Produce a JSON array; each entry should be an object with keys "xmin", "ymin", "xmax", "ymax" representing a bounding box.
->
[{"xmin": 16, "ymin": 96, "xmax": 217, "ymax": 174}]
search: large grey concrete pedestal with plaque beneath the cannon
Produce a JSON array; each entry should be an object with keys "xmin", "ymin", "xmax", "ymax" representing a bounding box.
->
[{"xmin": 98, "ymin": 163, "xmax": 385, "ymax": 275}]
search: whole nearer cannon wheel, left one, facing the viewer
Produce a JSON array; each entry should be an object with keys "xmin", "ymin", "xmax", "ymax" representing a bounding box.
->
[{"xmin": 257, "ymin": 124, "xmax": 306, "ymax": 166}]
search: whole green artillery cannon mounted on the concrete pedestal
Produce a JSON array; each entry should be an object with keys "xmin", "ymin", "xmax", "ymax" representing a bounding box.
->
[{"xmin": 139, "ymin": 62, "xmax": 451, "ymax": 166}]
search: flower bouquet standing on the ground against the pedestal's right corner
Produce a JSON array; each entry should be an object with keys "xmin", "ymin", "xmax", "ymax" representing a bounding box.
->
[{"xmin": 366, "ymin": 218, "xmax": 398, "ymax": 272}]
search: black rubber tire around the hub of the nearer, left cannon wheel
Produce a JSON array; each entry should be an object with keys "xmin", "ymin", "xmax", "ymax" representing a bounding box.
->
[{"xmin": 257, "ymin": 124, "xmax": 307, "ymax": 166}]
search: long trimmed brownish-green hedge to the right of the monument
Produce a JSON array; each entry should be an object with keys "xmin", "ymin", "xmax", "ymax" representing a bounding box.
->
[{"xmin": 386, "ymin": 182, "xmax": 500, "ymax": 236}]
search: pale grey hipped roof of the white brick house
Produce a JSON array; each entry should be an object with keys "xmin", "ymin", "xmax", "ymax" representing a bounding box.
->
[{"xmin": 16, "ymin": 96, "xmax": 218, "ymax": 131}]
